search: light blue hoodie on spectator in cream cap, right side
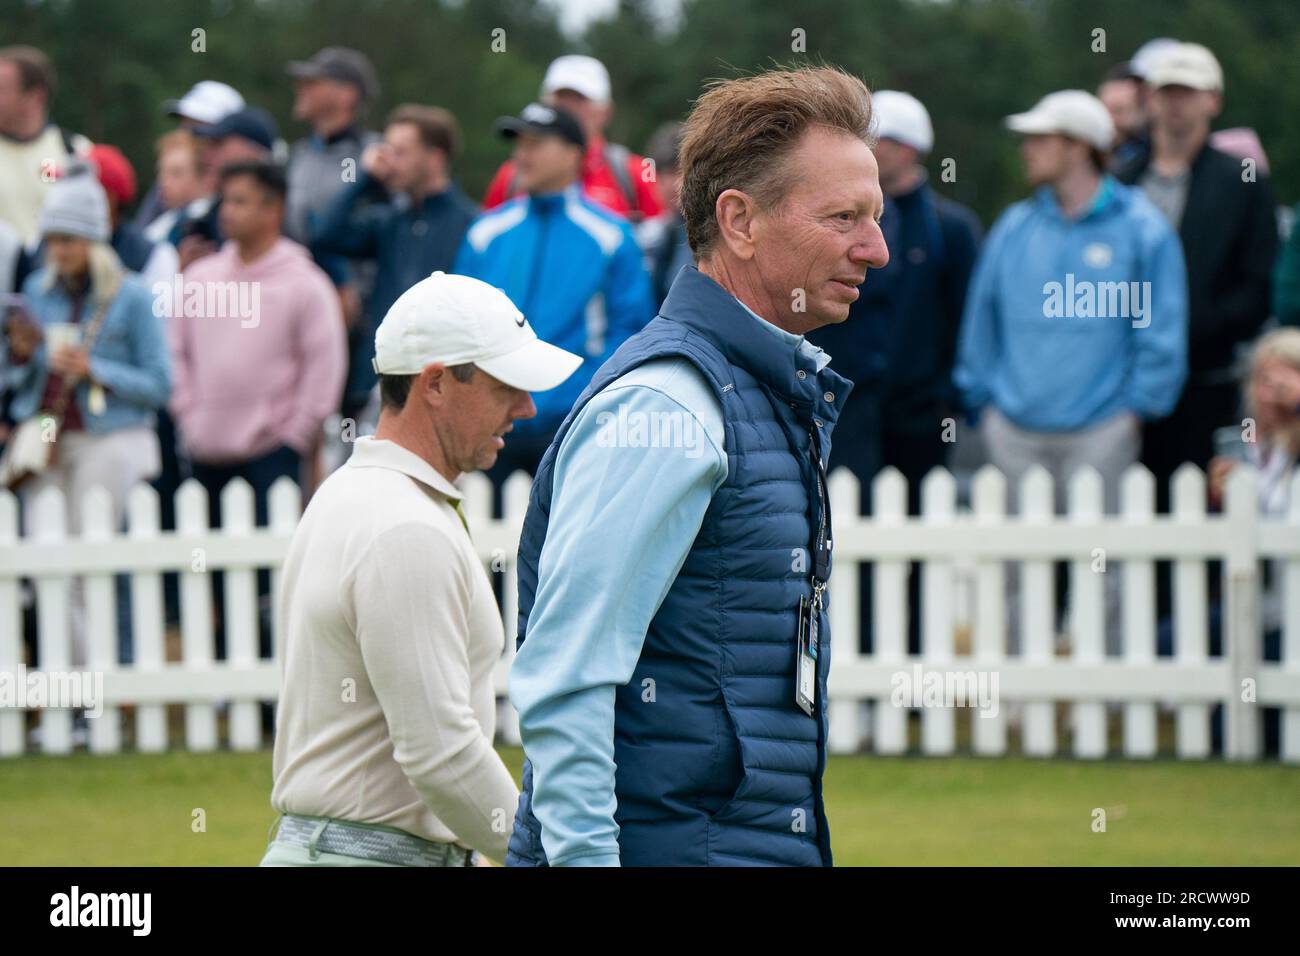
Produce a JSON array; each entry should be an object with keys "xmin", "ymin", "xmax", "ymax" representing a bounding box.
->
[{"xmin": 953, "ymin": 176, "xmax": 1187, "ymax": 432}]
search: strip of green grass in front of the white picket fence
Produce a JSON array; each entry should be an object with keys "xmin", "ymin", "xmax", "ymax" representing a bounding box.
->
[{"xmin": 0, "ymin": 749, "xmax": 1300, "ymax": 866}]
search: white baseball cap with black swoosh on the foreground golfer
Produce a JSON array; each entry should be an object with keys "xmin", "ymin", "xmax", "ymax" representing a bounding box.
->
[{"xmin": 371, "ymin": 272, "xmax": 582, "ymax": 392}]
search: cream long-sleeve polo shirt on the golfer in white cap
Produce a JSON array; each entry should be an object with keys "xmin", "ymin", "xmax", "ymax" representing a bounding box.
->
[{"xmin": 272, "ymin": 438, "xmax": 519, "ymax": 861}]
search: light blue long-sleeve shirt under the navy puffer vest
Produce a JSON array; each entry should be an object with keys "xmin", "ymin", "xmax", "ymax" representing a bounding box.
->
[{"xmin": 510, "ymin": 297, "xmax": 829, "ymax": 866}]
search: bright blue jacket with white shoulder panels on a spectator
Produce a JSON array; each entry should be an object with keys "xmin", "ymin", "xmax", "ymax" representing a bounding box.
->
[{"xmin": 455, "ymin": 185, "xmax": 655, "ymax": 436}]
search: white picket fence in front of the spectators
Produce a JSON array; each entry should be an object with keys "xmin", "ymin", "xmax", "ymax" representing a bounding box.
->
[{"xmin": 0, "ymin": 467, "xmax": 1300, "ymax": 762}]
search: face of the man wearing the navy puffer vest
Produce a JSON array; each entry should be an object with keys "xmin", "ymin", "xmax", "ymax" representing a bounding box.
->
[{"xmin": 754, "ymin": 129, "xmax": 889, "ymax": 333}]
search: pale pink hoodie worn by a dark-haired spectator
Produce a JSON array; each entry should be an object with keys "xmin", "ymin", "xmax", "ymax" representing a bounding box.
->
[{"xmin": 170, "ymin": 238, "xmax": 347, "ymax": 464}]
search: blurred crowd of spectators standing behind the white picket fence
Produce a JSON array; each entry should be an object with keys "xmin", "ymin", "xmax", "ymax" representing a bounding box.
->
[{"xmin": 0, "ymin": 39, "xmax": 1300, "ymax": 717}]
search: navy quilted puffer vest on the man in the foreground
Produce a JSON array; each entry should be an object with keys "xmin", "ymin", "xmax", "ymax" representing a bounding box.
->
[{"xmin": 507, "ymin": 267, "xmax": 853, "ymax": 866}]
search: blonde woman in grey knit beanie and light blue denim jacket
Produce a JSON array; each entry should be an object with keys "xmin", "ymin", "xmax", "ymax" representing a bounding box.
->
[{"xmin": 0, "ymin": 166, "xmax": 172, "ymax": 663}]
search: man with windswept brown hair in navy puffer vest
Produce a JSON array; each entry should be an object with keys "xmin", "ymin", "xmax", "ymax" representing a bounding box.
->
[{"xmin": 508, "ymin": 68, "xmax": 889, "ymax": 866}]
